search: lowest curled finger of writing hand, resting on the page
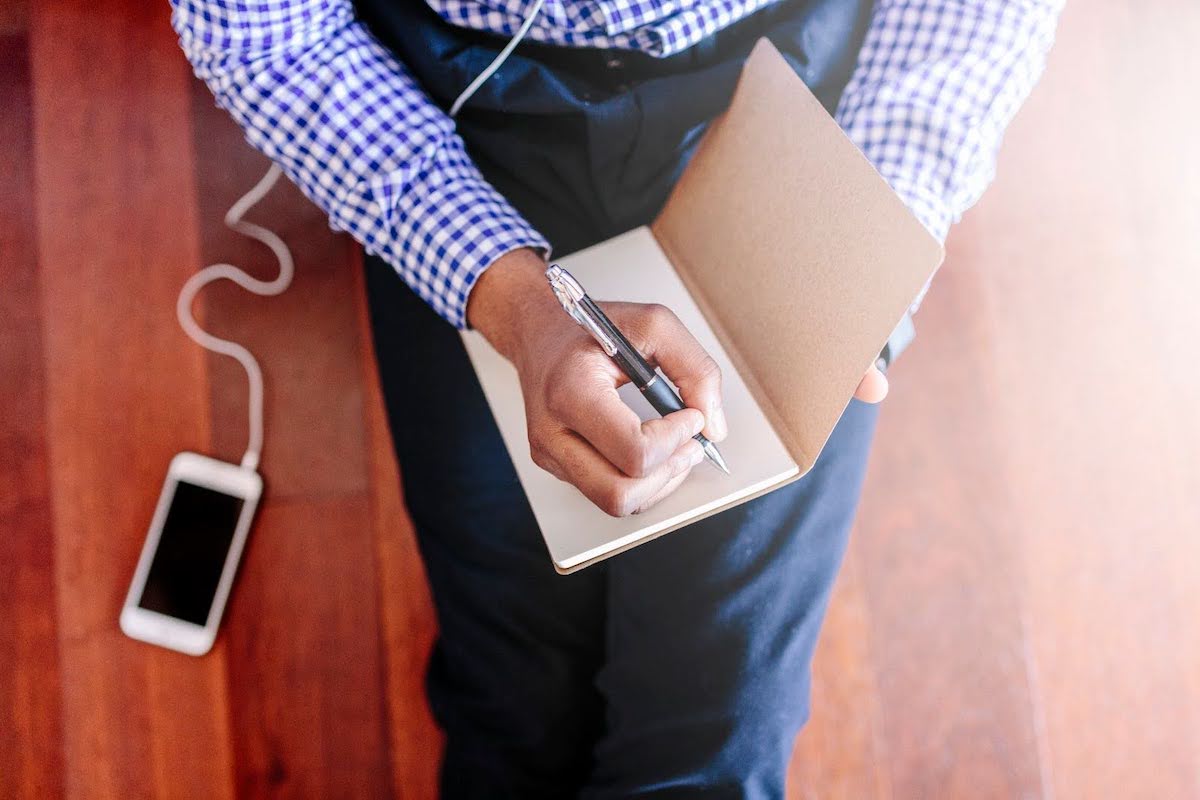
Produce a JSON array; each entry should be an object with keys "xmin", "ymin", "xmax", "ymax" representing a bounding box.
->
[{"xmin": 534, "ymin": 431, "xmax": 704, "ymax": 517}]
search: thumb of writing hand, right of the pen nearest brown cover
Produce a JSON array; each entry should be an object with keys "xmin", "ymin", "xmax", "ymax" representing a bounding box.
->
[{"xmin": 613, "ymin": 303, "xmax": 728, "ymax": 441}]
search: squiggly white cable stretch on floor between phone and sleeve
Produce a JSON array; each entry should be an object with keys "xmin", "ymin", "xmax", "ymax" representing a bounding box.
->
[{"xmin": 175, "ymin": 164, "xmax": 295, "ymax": 470}]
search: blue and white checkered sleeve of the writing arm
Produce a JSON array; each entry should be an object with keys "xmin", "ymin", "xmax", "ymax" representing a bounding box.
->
[{"xmin": 172, "ymin": 0, "xmax": 548, "ymax": 327}]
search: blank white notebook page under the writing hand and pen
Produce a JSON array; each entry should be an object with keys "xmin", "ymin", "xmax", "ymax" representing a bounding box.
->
[{"xmin": 463, "ymin": 227, "xmax": 799, "ymax": 570}]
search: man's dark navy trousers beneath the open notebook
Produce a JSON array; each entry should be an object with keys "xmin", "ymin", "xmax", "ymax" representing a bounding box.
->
[{"xmin": 359, "ymin": 0, "xmax": 876, "ymax": 799}]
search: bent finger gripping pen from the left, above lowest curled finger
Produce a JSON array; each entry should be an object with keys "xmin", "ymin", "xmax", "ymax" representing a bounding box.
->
[{"xmin": 552, "ymin": 385, "xmax": 704, "ymax": 477}]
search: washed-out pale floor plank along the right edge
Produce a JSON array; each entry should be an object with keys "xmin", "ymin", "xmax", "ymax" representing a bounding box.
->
[{"xmin": 961, "ymin": 2, "xmax": 1200, "ymax": 798}]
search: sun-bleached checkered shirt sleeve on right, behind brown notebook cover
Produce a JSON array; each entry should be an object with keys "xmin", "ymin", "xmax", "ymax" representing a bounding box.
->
[{"xmin": 836, "ymin": 0, "xmax": 1063, "ymax": 247}]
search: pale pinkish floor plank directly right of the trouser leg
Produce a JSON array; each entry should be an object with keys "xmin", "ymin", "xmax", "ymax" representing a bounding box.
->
[{"xmin": 856, "ymin": 257, "xmax": 1044, "ymax": 798}]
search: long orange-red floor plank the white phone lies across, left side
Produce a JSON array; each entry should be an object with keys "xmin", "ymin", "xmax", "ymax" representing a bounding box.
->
[{"xmin": 30, "ymin": 0, "xmax": 233, "ymax": 798}]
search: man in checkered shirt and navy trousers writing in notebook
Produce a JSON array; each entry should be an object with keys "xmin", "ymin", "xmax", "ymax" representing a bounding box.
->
[{"xmin": 173, "ymin": 0, "xmax": 1058, "ymax": 798}]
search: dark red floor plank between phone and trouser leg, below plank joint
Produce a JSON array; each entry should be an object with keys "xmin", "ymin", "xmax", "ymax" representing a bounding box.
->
[{"xmin": 226, "ymin": 498, "xmax": 391, "ymax": 798}]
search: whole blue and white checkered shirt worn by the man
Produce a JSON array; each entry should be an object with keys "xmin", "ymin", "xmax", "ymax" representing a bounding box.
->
[{"xmin": 172, "ymin": 0, "xmax": 1062, "ymax": 327}]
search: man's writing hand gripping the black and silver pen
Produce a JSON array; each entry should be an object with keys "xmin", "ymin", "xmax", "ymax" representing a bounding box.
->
[{"xmin": 467, "ymin": 249, "xmax": 726, "ymax": 517}]
